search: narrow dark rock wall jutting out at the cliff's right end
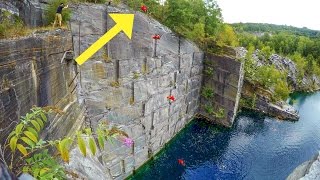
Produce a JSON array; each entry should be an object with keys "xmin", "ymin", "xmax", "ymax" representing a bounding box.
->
[{"xmin": 200, "ymin": 54, "xmax": 244, "ymax": 127}]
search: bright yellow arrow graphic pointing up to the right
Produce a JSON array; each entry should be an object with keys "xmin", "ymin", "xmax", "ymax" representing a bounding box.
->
[{"xmin": 76, "ymin": 14, "xmax": 134, "ymax": 65}]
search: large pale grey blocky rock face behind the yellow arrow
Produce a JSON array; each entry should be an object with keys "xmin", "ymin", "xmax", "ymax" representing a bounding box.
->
[{"xmin": 70, "ymin": 4, "xmax": 203, "ymax": 179}]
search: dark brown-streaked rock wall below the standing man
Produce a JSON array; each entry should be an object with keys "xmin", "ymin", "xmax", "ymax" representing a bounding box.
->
[{"xmin": 0, "ymin": 29, "xmax": 82, "ymax": 143}]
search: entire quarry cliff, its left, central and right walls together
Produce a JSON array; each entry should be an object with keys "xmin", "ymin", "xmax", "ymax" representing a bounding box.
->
[{"xmin": 0, "ymin": 4, "xmax": 243, "ymax": 179}]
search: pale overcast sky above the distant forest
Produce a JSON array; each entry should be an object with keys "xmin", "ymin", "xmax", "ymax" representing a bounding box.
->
[{"xmin": 216, "ymin": 0, "xmax": 320, "ymax": 30}]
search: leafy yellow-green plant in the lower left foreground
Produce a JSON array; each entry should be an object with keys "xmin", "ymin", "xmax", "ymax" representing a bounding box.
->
[{"xmin": 0, "ymin": 107, "xmax": 133, "ymax": 179}]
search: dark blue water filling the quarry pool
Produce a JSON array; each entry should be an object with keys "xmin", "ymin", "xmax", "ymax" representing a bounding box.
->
[{"xmin": 129, "ymin": 92, "xmax": 320, "ymax": 180}]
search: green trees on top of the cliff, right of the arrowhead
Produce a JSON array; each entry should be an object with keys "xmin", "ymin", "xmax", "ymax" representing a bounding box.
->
[{"xmin": 125, "ymin": 0, "xmax": 225, "ymax": 47}]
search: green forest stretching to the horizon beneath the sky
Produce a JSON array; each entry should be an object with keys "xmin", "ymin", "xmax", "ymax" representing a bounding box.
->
[{"xmin": 235, "ymin": 24, "xmax": 320, "ymax": 80}]
